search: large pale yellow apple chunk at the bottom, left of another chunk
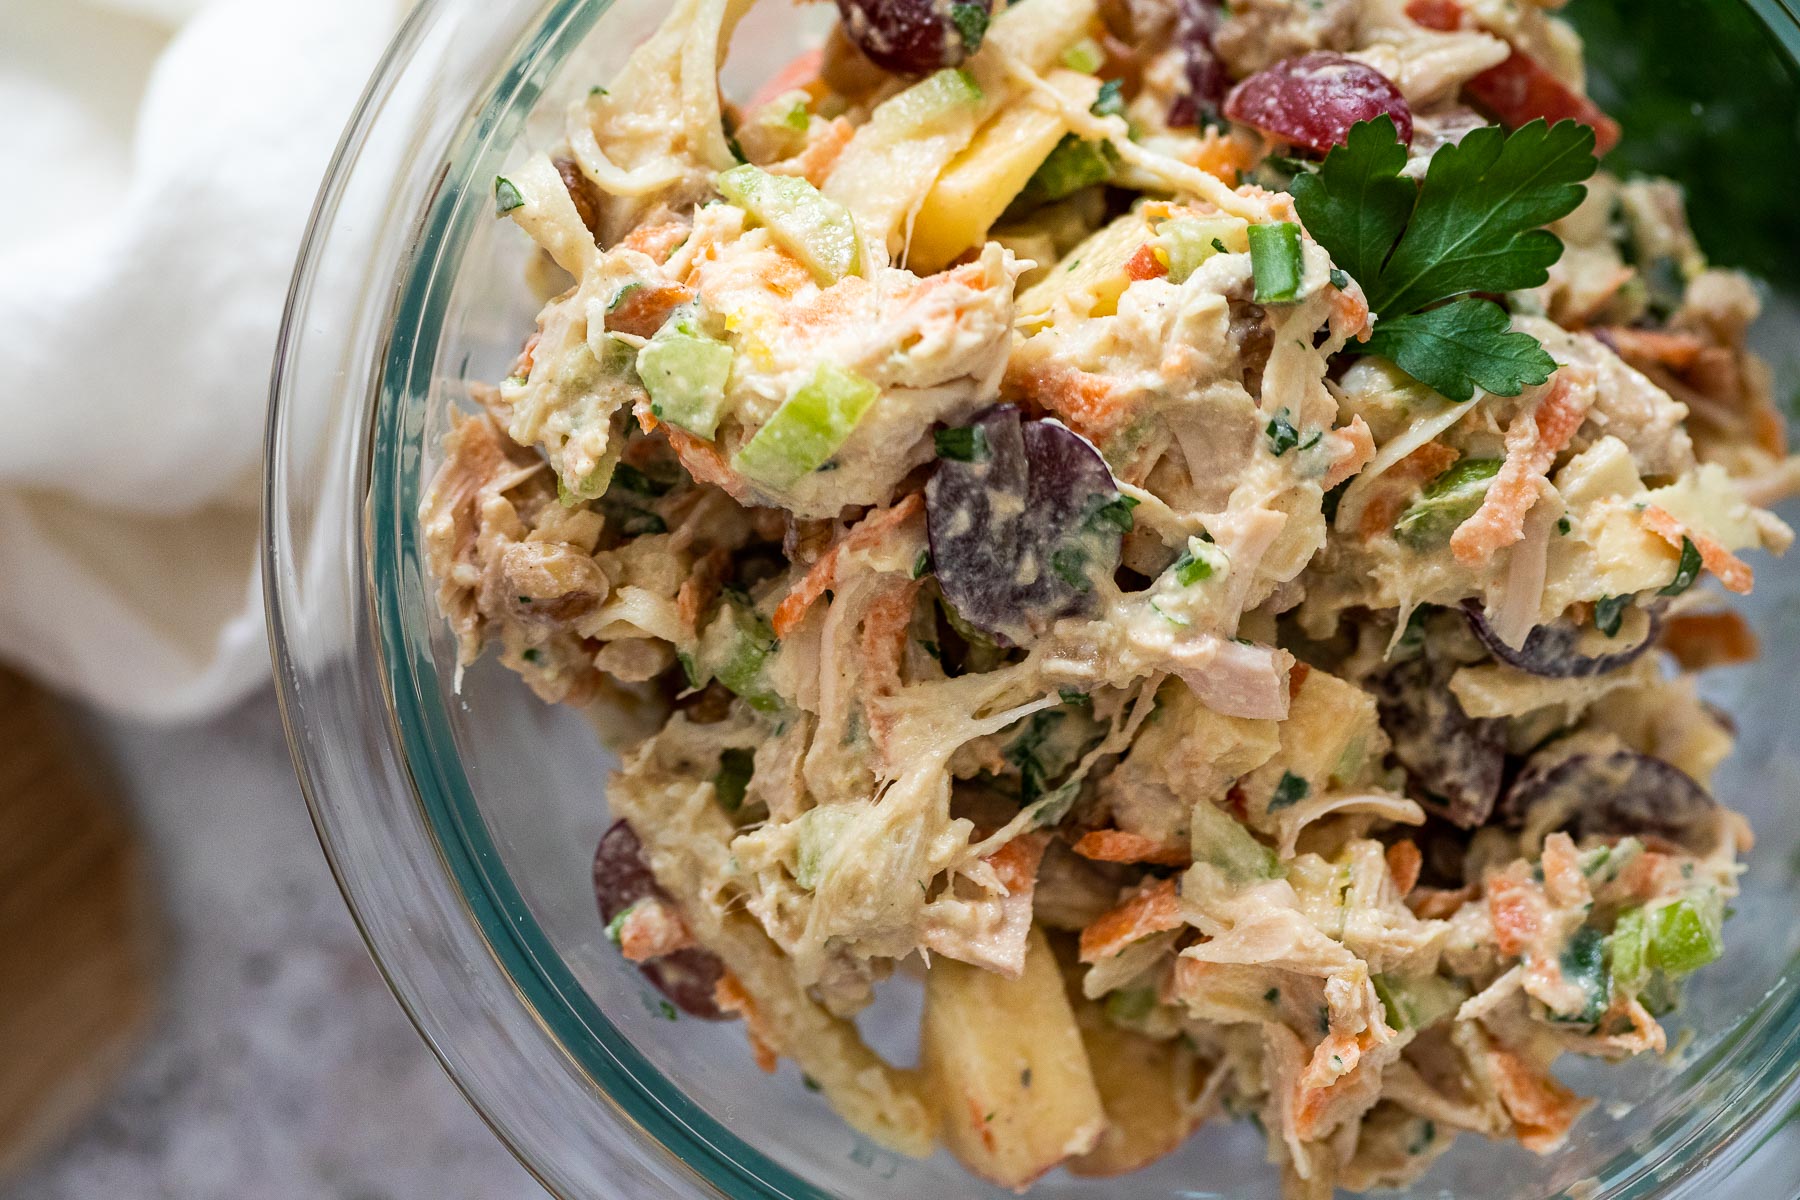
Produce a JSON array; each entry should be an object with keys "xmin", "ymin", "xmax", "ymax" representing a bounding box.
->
[{"xmin": 920, "ymin": 928, "xmax": 1107, "ymax": 1189}]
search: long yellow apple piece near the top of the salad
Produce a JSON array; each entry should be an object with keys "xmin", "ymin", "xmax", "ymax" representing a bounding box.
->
[{"xmin": 907, "ymin": 70, "xmax": 1100, "ymax": 273}]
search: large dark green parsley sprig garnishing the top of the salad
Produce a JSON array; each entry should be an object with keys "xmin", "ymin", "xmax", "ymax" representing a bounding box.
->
[{"xmin": 1292, "ymin": 117, "xmax": 1598, "ymax": 401}]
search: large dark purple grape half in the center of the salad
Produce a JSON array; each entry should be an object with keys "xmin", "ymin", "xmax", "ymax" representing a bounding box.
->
[{"xmin": 925, "ymin": 405, "xmax": 1132, "ymax": 646}]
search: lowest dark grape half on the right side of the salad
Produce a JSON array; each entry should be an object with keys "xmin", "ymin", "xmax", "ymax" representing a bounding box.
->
[{"xmin": 1501, "ymin": 743, "xmax": 1719, "ymax": 855}]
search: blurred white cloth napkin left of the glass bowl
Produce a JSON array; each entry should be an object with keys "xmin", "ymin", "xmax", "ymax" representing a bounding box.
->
[{"xmin": 0, "ymin": 0, "xmax": 398, "ymax": 720}]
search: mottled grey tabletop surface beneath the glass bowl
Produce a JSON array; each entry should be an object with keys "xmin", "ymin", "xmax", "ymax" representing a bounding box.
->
[{"xmin": 0, "ymin": 694, "xmax": 1800, "ymax": 1200}]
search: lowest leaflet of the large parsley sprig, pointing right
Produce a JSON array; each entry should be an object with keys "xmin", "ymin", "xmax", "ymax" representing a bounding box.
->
[{"xmin": 1363, "ymin": 297, "xmax": 1557, "ymax": 401}]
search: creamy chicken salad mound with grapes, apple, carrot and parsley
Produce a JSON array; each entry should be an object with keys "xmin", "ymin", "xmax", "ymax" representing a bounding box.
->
[{"xmin": 419, "ymin": 0, "xmax": 1800, "ymax": 1198}]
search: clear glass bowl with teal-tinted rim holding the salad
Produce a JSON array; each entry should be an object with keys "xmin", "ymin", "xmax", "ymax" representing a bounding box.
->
[{"xmin": 265, "ymin": 0, "xmax": 1800, "ymax": 1200}]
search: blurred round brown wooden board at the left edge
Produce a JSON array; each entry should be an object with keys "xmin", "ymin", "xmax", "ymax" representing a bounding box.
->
[{"xmin": 0, "ymin": 667, "xmax": 158, "ymax": 1177}]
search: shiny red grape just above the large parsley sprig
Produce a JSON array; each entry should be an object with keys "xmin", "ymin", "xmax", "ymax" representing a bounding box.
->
[{"xmin": 1226, "ymin": 50, "xmax": 1413, "ymax": 155}]
